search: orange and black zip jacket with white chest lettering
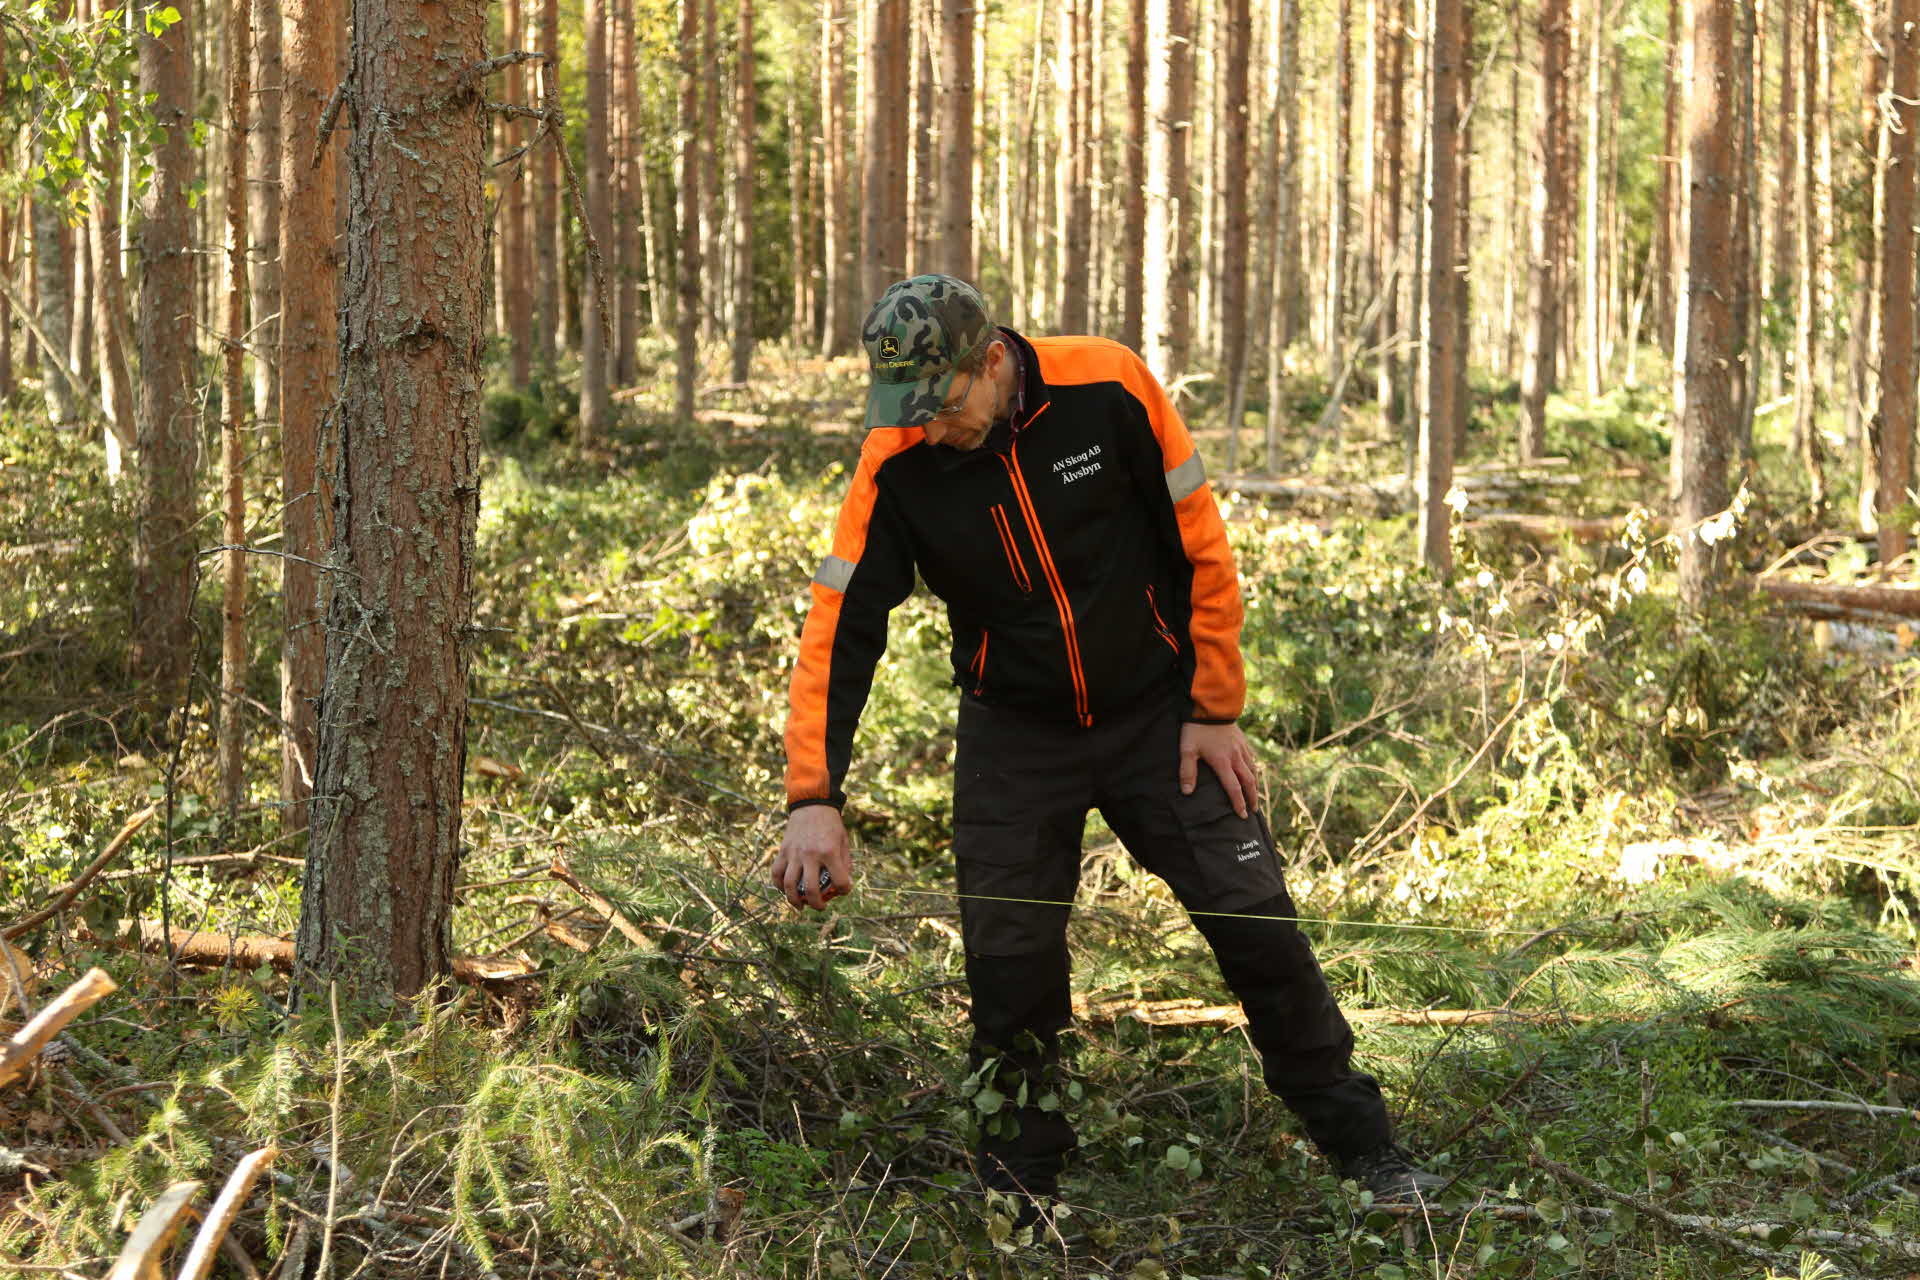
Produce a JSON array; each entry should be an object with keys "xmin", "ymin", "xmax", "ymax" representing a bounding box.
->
[{"xmin": 787, "ymin": 328, "xmax": 1246, "ymax": 810}]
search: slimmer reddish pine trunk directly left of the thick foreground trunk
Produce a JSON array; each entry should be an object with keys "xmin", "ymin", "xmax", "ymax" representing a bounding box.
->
[{"xmin": 278, "ymin": 0, "xmax": 340, "ymax": 831}]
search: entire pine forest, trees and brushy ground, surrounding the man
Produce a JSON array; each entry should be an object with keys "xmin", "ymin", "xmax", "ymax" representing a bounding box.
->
[{"xmin": 0, "ymin": 0, "xmax": 1920, "ymax": 1280}]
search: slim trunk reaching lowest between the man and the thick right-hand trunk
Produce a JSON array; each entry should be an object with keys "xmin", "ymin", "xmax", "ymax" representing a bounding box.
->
[{"xmin": 1417, "ymin": 0, "xmax": 1463, "ymax": 578}]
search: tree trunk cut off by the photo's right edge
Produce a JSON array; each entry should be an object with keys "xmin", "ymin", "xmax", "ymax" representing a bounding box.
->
[{"xmin": 1874, "ymin": 0, "xmax": 1920, "ymax": 564}]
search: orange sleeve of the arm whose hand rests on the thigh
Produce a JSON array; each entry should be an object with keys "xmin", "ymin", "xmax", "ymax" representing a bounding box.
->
[{"xmin": 1123, "ymin": 353, "xmax": 1246, "ymax": 723}]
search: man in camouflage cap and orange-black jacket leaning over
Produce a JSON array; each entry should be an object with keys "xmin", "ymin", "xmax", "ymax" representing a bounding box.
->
[{"xmin": 774, "ymin": 276, "xmax": 1442, "ymax": 1221}]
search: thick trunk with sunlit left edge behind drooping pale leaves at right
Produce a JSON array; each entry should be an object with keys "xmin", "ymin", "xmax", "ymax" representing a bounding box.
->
[{"xmin": 1680, "ymin": 0, "xmax": 1741, "ymax": 608}]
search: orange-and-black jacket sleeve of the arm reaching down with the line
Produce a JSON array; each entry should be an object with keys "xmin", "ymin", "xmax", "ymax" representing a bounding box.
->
[{"xmin": 787, "ymin": 428, "xmax": 920, "ymax": 810}]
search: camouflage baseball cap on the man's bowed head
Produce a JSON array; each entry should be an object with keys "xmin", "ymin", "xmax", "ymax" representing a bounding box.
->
[{"xmin": 860, "ymin": 276, "xmax": 995, "ymax": 426}]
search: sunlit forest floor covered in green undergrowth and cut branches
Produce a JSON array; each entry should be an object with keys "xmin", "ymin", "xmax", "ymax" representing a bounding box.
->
[{"xmin": 0, "ymin": 349, "xmax": 1920, "ymax": 1280}]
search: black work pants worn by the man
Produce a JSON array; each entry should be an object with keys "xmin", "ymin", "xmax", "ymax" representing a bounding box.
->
[{"xmin": 954, "ymin": 699, "xmax": 1392, "ymax": 1194}]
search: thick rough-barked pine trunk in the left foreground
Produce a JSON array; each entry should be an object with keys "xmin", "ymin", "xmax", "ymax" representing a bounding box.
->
[{"xmin": 298, "ymin": 0, "xmax": 488, "ymax": 1004}]
